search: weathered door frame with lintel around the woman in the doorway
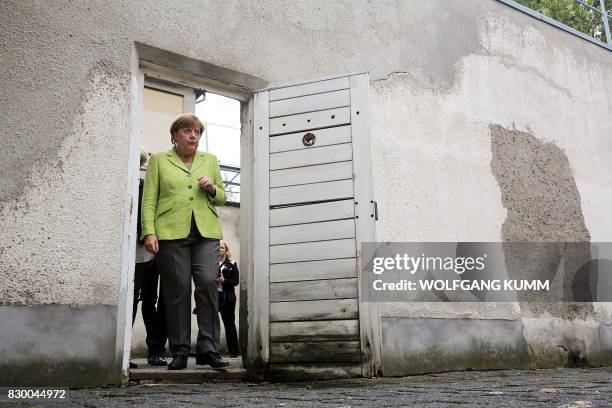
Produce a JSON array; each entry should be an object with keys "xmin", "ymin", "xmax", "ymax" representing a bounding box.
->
[{"xmin": 120, "ymin": 43, "xmax": 267, "ymax": 383}]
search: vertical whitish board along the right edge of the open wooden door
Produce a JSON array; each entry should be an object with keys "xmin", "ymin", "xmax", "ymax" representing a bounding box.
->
[{"xmin": 350, "ymin": 73, "xmax": 382, "ymax": 377}]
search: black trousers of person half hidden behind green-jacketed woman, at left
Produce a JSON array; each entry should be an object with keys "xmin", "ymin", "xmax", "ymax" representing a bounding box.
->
[{"xmin": 132, "ymin": 260, "xmax": 167, "ymax": 355}]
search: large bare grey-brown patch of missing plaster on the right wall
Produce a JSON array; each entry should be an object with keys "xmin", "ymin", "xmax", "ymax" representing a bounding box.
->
[{"xmin": 490, "ymin": 125, "xmax": 593, "ymax": 319}]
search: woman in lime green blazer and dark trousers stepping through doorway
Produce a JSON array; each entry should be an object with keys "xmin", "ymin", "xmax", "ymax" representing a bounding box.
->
[{"xmin": 142, "ymin": 114, "xmax": 229, "ymax": 370}]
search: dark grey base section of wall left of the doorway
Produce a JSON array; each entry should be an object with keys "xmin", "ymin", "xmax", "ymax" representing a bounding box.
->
[{"xmin": 0, "ymin": 305, "xmax": 121, "ymax": 387}]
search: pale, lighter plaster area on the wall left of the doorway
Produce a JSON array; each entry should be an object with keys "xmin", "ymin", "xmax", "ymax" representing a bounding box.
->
[{"xmin": 0, "ymin": 67, "xmax": 130, "ymax": 305}]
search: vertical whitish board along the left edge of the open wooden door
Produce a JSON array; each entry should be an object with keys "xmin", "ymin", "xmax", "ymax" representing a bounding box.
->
[{"xmin": 247, "ymin": 91, "xmax": 270, "ymax": 378}]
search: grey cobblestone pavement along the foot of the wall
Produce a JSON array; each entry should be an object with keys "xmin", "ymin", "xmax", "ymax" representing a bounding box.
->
[{"xmin": 1, "ymin": 368, "xmax": 612, "ymax": 408}]
